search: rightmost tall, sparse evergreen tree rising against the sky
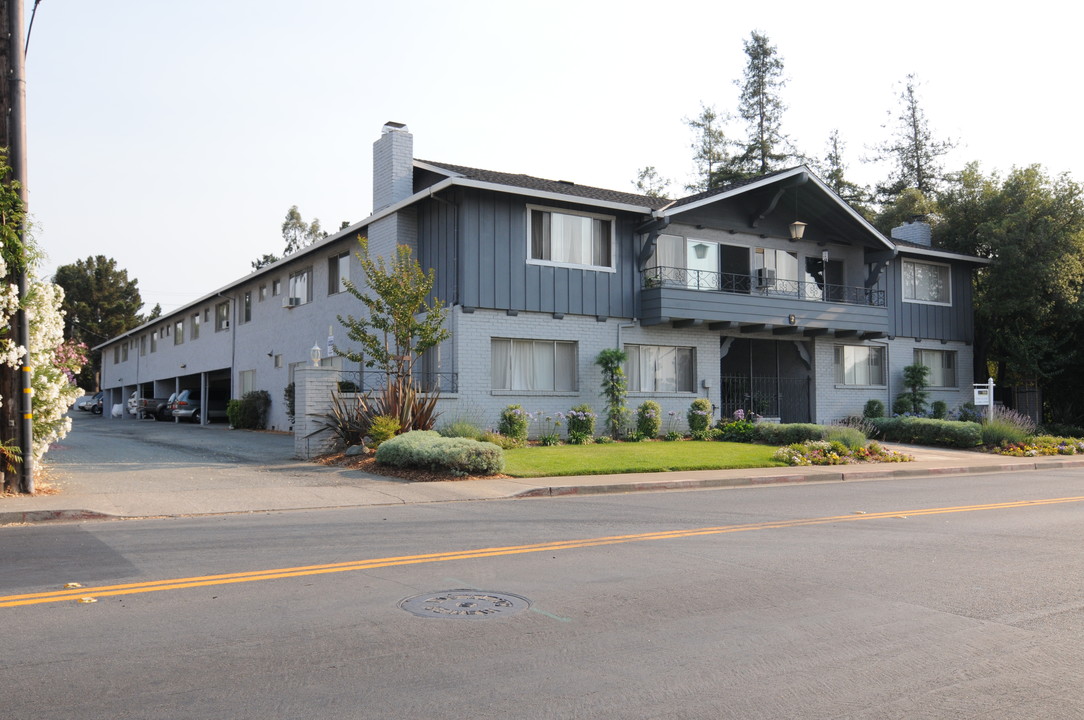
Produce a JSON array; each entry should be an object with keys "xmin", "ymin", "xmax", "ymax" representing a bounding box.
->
[{"xmin": 873, "ymin": 74, "xmax": 956, "ymax": 203}]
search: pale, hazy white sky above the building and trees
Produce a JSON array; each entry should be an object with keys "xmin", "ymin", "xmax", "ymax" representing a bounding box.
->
[{"xmin": 24, "ymin": 0, "xmax": 1084, "ymax": 312}]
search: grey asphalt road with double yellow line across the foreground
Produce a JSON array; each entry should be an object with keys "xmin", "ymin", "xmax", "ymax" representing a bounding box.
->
[{"xmin": 0, "ymin": 471, "xmax": 1084, "ymax": 720}]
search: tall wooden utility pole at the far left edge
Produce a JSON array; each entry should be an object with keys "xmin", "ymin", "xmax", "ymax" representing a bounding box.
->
[{"xmin": 0, "ymin": 0, "xmax": 34, "ymax": 492}]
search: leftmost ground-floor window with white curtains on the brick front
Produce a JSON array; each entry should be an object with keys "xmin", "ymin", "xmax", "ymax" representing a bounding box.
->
[{"xmin": 490, "ymin": 337, "xmax": 577, "ymax": 391}]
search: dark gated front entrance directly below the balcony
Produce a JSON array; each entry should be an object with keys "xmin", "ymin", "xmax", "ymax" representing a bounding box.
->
[{"xmin": 721, "ymin": 337, "xmax": 812, "ymax": 423}]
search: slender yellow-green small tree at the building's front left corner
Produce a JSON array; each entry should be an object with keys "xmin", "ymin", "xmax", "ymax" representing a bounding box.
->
[{"xmin": 335, "ymin": 237, "xmax": 451, "ymax": 433}]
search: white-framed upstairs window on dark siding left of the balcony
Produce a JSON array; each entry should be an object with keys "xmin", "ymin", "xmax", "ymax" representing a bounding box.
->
[{"xmin": 528, "ymin": 206, "xmax": 614, "ymax": 270}]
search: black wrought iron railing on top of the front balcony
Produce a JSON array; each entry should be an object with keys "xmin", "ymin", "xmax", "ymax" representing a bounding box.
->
[{"xmin": 641, "ymin": 267, "xmax": 885, "ymax": 308}]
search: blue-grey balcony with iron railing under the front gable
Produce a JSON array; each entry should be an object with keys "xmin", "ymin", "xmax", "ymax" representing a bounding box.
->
[{"xmin": 641, "ymin": 267, "xmax": 889, "ymax": 339}]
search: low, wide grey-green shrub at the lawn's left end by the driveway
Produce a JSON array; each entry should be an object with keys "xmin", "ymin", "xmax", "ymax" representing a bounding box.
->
[{"xmin": 376, "ymin": 430, "xmax": 504, "ymax": 475}]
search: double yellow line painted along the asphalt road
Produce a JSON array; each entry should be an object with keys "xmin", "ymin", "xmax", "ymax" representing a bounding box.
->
[{"xmin": 0, "ymin": 497, "xmax": 1084, "ymax": 607}]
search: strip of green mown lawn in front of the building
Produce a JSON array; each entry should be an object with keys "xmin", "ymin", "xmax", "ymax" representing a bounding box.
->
[{"xmin": 504, "ymin": 440, "xmax": 785, "ymax": 477}]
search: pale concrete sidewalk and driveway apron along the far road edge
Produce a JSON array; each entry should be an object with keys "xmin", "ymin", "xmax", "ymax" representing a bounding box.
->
[{"xmin": 8, "ymin": 429, "xmax": 1084, "ymax": 525}]
